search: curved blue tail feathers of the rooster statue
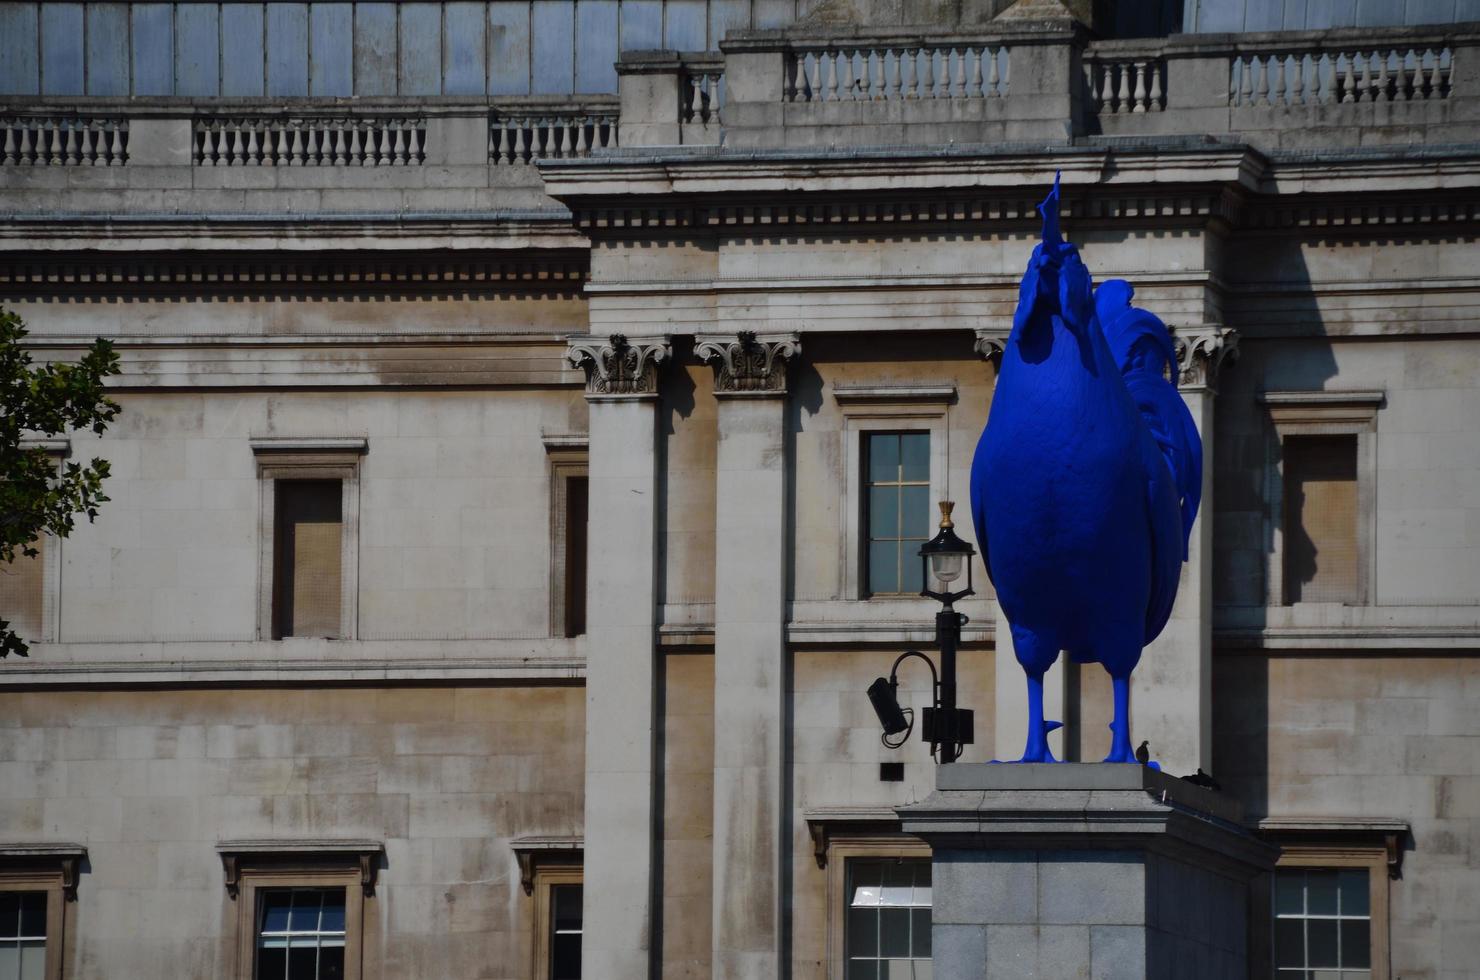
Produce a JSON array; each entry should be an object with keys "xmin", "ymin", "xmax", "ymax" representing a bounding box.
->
[{"xmin": 1095, "ymin": 280, "xmax": 1202, "ymax": 561}]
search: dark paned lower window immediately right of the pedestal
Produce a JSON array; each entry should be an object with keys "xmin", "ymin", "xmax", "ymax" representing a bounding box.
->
[{"xmin": 1274, "ymin": 867, "xmax": 1372, "ymax": 980}]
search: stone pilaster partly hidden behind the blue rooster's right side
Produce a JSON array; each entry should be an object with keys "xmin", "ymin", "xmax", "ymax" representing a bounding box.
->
[{"xmin": 1131, "ymin": 324, "xmax": 1239, "ymax": 776}]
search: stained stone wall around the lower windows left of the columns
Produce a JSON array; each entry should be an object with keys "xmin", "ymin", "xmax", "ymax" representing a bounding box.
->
[{"xmin": 0, "ymin": 685, "xmax": 585, "ymax": 980}]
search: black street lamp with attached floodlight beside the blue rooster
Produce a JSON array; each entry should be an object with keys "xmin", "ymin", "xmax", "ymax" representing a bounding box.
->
[{"xmin": 869, "ymin": 500, "xmax": 977, "ymax": 765}]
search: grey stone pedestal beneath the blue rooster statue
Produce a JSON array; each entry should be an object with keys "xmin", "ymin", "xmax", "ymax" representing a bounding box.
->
[{"xmin": 898, "ymin": 762, "xmax": 1277, "ymax": 980}]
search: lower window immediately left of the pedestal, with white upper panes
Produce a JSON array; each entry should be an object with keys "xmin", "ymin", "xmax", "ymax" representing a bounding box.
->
[{"xmin": 844, "ymin": 857, "xmax": 931, "ymax": 980}]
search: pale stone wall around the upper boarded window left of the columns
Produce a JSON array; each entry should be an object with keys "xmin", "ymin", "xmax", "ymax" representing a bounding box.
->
[{"xmin": 46, "ymin": 389, "xmax": 585, "ymax": 642}]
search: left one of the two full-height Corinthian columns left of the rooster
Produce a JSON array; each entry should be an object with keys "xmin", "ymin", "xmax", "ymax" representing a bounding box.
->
[{"xmin": 567, "ymin": 335, "xmax": 669, "ymax": 977}]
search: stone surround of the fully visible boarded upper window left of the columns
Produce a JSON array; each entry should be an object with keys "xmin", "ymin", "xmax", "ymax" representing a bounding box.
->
[{"xmin": 250, "ymin": 437, "xmax": 370, "ymax": 640}]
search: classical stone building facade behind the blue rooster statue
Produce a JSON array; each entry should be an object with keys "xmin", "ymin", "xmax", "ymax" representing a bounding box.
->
[{"xmin": 0, "ymin": 0, "xmax": 1480, "ymax": 980}]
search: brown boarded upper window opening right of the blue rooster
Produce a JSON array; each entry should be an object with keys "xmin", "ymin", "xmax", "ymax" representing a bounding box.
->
[{"xmin": 1283, "ymin": 435, "xmax": 1360, "ymax": 605}]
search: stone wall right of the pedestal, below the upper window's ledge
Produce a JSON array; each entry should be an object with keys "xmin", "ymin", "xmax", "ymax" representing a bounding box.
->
[{"xmin": 1214, "ymin": 653, "xmax": 1480, "ymax": 980}]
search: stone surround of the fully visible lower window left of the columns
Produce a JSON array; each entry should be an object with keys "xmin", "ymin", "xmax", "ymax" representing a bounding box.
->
[{"xmin": 216, "ymin": 839, "xmax": 385, "ymax": 980}]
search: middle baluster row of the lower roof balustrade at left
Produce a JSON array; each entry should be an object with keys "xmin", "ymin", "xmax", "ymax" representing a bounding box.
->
[{"xmin": 194, "ymin": 114, "xmax": 426, "ymax": 167}]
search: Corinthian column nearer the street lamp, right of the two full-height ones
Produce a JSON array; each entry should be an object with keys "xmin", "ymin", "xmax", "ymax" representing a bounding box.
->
[{"xmin": 694, "ymin": 333, "xmax": 801, "ymax": 980}]
